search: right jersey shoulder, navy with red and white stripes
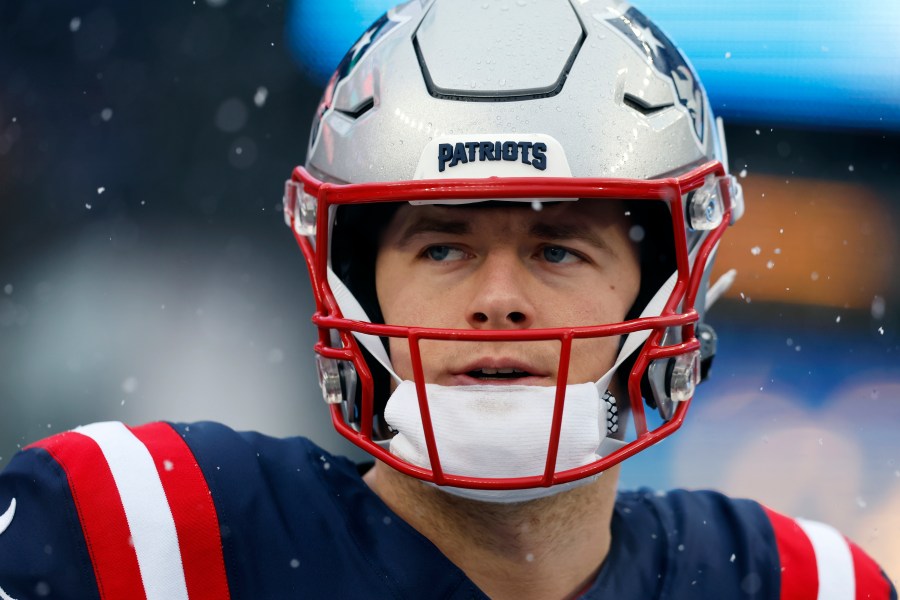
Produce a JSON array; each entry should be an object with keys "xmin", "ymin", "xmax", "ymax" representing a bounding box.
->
[{"xmin": 596, "ymin": 490, "xmax": 896, "ymax": 600}]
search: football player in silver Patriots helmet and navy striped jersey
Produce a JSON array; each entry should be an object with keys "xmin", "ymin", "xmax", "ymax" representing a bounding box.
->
[{"xmin": 0, "ymin": 0, "xmax": 896, "ymax": 600}]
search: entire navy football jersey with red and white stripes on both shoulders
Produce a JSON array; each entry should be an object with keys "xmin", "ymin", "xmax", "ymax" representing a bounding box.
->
[{"xmin": 0, "ymin": 423, "xmax": 896, "ymax": 600}]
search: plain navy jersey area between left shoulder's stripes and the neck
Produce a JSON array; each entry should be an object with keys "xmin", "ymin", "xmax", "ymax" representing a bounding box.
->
[{"xmin": 175, "ymin": 424, "xmax": 484, "ymax": 600}]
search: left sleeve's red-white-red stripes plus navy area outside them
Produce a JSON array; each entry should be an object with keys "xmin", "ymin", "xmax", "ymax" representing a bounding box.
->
[{"xmin": 0, "ymin": 422, "xmax": 239, "ymax": 598}]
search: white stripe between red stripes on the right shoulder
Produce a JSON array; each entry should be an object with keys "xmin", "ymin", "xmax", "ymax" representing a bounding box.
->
[{"xmin": 797, "ymin": 519, "xmax": 856, "ymax": 600}]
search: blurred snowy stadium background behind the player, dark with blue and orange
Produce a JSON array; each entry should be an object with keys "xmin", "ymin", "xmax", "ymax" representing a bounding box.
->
[{"xmin": 0, "ymin": 0, "xmax": 900, "ymax": 581}]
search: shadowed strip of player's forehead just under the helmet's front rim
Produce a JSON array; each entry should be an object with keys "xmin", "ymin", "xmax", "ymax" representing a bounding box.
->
[{"xmin": 382, "ymin": 199, "xmax": 630, "ymax": 243}]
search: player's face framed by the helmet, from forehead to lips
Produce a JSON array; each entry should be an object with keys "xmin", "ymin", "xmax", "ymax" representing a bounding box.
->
[{"xmin": 375, "ymin": 200, "xmax": 640, "ymax": 386}]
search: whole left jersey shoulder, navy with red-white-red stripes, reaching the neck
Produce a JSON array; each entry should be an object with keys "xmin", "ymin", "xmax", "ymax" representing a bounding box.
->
[{"xmin": 0, "ymin": 422, "xmax": 486, "ymax": 600}]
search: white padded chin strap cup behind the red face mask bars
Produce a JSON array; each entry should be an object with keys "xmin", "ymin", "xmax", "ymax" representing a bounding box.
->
[{"xmin": 385, "ymin": 381, "xmax": 606, "ymax": 478}]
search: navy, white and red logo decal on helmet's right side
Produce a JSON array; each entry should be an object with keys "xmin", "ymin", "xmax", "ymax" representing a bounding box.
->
[{"xmin": 604, "ymin": 3, "xmax": 706, "ymax": 144}]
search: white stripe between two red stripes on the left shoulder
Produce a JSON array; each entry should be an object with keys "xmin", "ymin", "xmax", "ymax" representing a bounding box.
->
[{"xmin": 75, "ymin": 422, "xmax": 188, "ymax": 600}]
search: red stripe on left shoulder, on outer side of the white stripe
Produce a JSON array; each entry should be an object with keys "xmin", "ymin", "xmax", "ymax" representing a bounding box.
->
[{"xmin": 30, "ymin": 431, "xmax": 146, "ymax": 600}]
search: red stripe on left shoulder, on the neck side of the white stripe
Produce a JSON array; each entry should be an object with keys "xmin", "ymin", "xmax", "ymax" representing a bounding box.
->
[{"xmin": 131, "ymin": 423, "xmax": 229, "ymax": 600}]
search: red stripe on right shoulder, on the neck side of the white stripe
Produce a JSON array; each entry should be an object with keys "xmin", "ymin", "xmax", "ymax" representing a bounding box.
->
[{"xmin": 763, "ymin": 506, "xmax": 819, "ymax": 600}]
